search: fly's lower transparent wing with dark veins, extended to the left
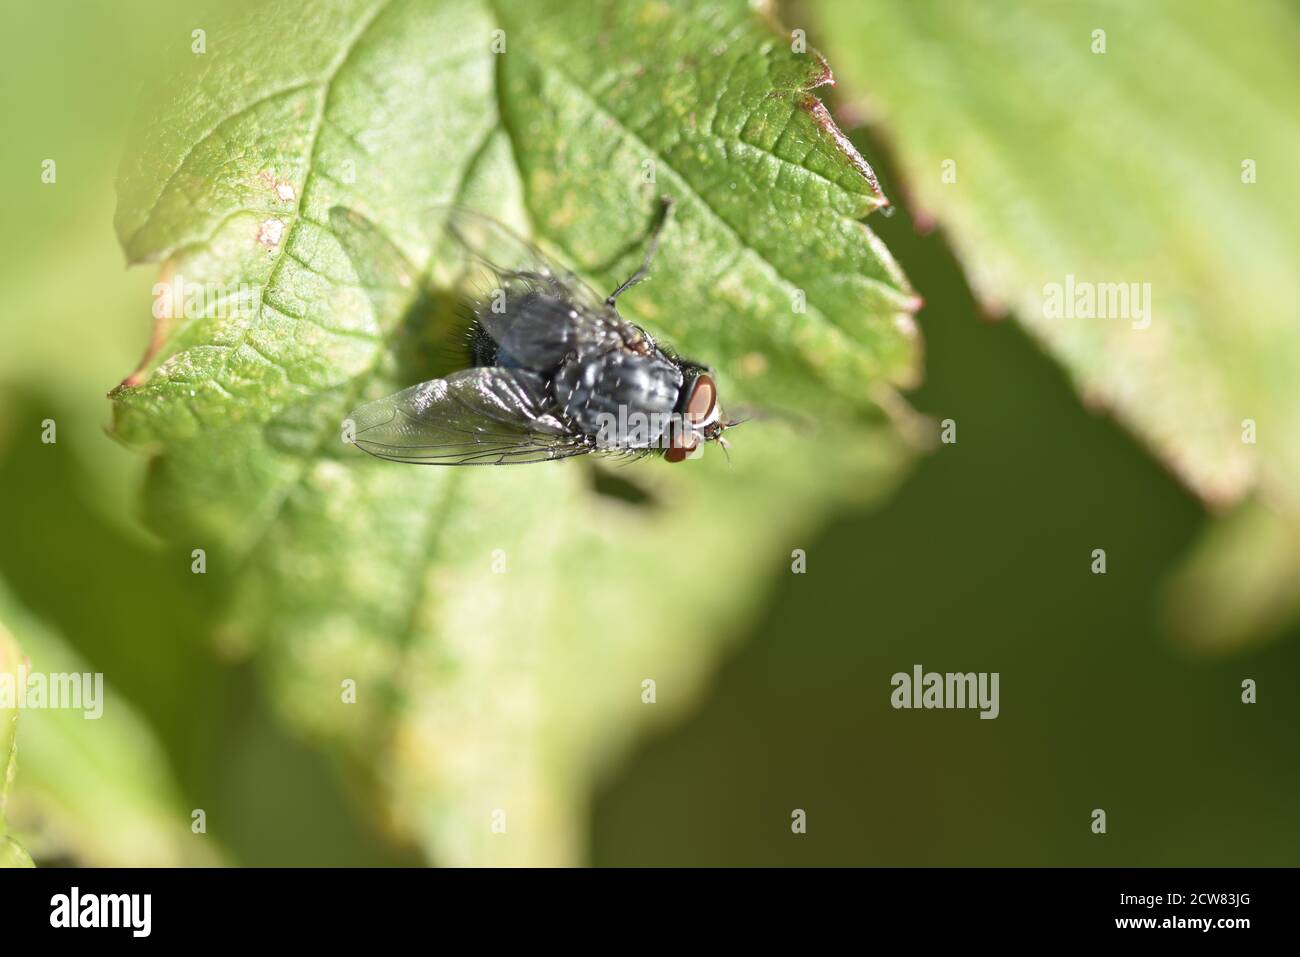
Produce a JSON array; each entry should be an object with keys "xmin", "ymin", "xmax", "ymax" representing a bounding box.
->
[{"xmin": 350, "ymin": 367, "xmax": 590, "ymax": 465}]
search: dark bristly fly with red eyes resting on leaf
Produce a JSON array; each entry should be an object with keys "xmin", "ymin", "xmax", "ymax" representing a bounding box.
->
[{"xmin": 332, "ymin": 198, "xmax": 736, "ymax": 465}]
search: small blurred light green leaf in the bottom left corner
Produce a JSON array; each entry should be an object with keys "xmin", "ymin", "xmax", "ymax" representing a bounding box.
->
[{"xmin": 0, "ymin": 583, "xmax": 217, "ymax": 867}]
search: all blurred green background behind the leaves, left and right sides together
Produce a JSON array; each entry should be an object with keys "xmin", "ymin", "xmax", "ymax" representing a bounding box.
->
[{"xmin": 0, "ymin": 0, "xmax": 1300, "ymax": 865}]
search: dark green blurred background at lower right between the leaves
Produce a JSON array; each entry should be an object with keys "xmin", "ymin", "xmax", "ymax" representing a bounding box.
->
[{"xmin": 593, "ymin": 143, "xmax": 1300, "ymax": 866}]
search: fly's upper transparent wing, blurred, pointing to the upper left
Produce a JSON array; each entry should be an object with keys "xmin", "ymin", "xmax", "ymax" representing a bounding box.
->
[{"xmin": 441, "ymin": 207, "xmax": 642, "ymax": 363}]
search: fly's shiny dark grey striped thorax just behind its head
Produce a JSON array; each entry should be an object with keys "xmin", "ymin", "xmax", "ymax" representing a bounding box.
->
[{"xmin": 554, "ymin": 351, "xmax": 681, "ymax": 449}]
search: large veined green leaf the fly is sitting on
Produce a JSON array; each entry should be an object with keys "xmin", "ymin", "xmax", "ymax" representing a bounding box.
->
[{"xmin": 113, "ymin": 0, "xmax": 918, "ymax": 863}]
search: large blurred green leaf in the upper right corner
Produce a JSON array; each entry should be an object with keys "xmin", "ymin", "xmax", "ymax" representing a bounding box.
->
[{"xmin": 815, "ymin": 0, "xmax": 1300, "ymax": 650}]
